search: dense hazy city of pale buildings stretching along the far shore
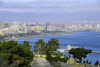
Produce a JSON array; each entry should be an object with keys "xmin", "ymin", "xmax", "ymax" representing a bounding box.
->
[{"xmin": 0, "ymin": 21, "xmax": 100, "ymax": 39}]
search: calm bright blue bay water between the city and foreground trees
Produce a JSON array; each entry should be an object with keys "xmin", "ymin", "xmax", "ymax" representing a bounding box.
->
[{"xmin": 18, "ymin": 32, "xmax": 100, "ymax": 64}]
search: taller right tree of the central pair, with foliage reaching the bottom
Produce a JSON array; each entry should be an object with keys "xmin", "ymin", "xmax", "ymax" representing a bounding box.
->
[{"xmin": 46, "ymin": 38, "xmax": 68, "ymax": 67}]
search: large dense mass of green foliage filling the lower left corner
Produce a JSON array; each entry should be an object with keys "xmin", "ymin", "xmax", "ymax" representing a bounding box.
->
[{"xmin": 0, "ymin": 41, "xmax": 33, "ymax": 67}]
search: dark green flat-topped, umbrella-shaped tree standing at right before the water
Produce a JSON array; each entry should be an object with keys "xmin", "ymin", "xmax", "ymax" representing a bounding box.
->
[{"xmin": 69, "ymin": 48, "xmax": 92, "ymax": 63}]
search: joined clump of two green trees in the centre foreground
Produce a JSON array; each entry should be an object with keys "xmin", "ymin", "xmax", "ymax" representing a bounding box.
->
[{"xmin": 34, "ymin": 38, "xmax": 68, "ymax": 67}]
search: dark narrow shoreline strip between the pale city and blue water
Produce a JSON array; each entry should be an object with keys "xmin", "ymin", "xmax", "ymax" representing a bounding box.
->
[{"xmin": 0, "ymin": 31, "xmax": 72, "ymax": 41}]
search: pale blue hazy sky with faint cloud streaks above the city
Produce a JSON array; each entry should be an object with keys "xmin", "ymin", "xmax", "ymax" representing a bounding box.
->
[{"xmin": 0, "ymin": 0, "xmax": 100, "ymax": 23}]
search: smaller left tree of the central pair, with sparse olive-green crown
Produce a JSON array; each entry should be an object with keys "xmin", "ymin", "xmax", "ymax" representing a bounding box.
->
[{"xmin": 34, "ymin": 39, "xmax": 45, "ymax": 54}]
